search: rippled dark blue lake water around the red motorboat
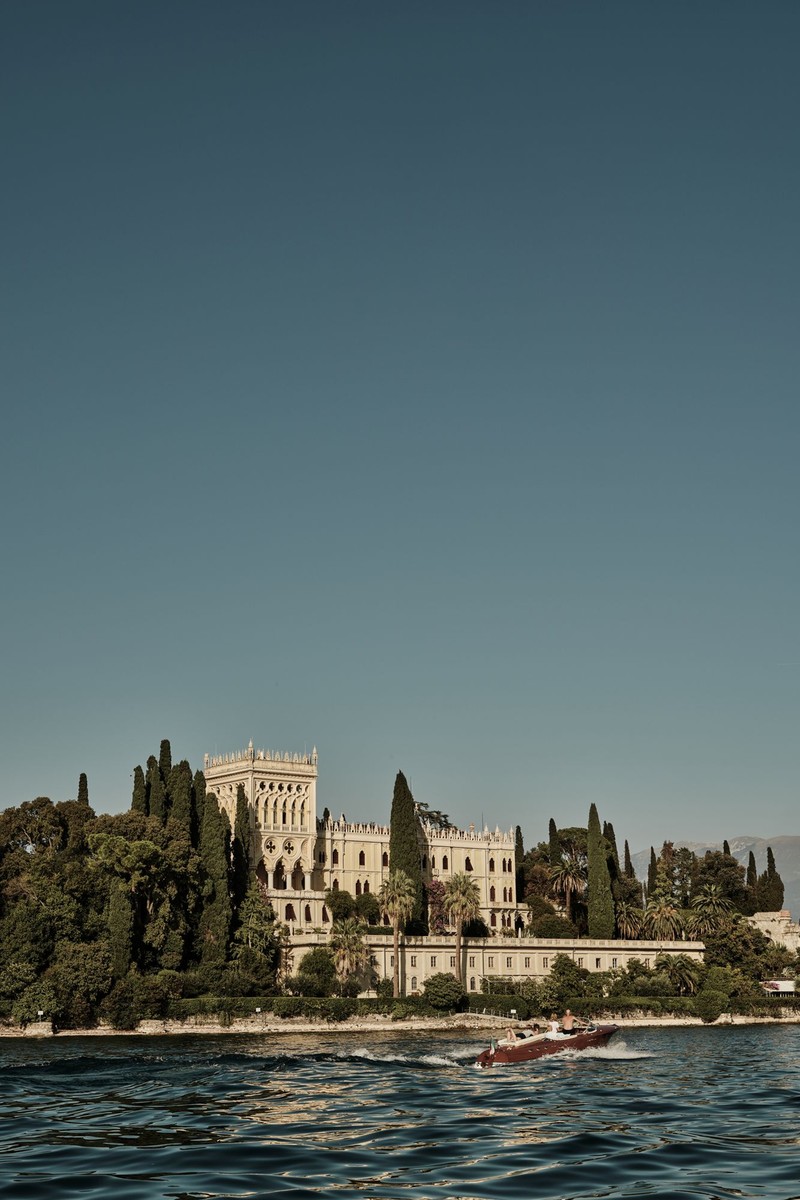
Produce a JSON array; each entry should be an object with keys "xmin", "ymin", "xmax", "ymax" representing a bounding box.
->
[{"xmin": 0, "ymin": 1026, "xmax": 800, "ymax": 1200}]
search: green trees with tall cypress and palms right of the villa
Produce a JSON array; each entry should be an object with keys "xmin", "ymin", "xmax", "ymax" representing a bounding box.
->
[{"xmin": 521, "ymin": 804, "xmax": 783, "ymax": 941}]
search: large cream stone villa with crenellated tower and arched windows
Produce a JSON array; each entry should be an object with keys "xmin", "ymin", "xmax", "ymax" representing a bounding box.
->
[{"xmin": 204, "ymin": 742, "xmax": 703, "ymax": 991}]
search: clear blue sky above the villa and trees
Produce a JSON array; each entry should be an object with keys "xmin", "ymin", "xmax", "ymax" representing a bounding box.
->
[{"xmin": 0, "ymin": 0, "xmax": 800, "ymax": 851}]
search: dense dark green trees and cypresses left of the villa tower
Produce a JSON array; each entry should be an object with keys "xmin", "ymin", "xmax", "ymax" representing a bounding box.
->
[{"xmin": 0, "ymin": 740, "xmax": 283, "ymax": 1027}]
